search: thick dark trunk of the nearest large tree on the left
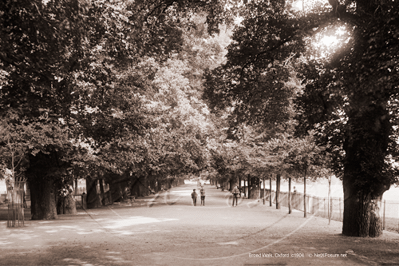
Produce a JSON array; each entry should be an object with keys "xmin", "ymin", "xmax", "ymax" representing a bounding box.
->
[{"xmin": 28, "ymin": 176, "xmax": 57, "ymax": 220}]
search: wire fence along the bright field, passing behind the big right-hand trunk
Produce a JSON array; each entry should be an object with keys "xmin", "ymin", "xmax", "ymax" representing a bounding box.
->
[{"xmin": 261, "ymin": 191, "xmax": 399, "ymax": 233}]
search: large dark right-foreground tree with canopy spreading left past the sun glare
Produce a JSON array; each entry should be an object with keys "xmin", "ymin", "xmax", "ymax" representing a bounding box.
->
[{"xmin": 206, "ymin": 0, "xmax": 399, "ymax": 236}]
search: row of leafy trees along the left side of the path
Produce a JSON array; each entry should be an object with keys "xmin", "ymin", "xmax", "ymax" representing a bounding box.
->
[{"xmin": 0, "ymin": 0, "xmax": 233, "ymax": 219}]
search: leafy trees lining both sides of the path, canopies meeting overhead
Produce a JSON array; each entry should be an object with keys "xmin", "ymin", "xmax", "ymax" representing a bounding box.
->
[{"xmin": 0, "ymin": 0, "xmax": 399, "ymax": 236}]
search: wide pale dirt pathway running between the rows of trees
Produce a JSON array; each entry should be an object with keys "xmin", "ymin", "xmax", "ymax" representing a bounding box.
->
[{"xmin": 0, "ymin": 185, "xmax": 399, "ymax": 265}]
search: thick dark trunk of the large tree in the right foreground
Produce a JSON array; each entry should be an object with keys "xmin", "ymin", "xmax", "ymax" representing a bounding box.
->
[{"xmin": 342, "ymin": 102, "xmax": 392, "ymax": 237}]
